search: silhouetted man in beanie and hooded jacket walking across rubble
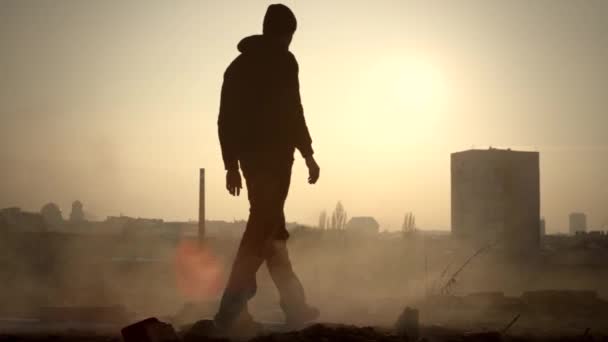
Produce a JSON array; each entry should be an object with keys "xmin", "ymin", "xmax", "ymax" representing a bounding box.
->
[{"xmin": 215, "ymin": 4, "xmax": 319, "ymax": 329}]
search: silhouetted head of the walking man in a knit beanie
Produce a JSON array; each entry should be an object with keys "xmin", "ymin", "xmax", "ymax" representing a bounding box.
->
[{"xmin": 263, "ymin": 4, "xmax": 298, "ymax": 48}]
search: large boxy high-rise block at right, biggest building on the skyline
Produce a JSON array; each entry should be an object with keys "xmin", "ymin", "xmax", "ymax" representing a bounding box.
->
[{"xmin": 451, "ymin": 148, "xmax": 541, "ymax": 250}]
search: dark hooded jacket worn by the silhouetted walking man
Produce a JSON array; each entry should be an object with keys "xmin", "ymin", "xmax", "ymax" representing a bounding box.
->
[{"xmin": 218, "ymin": 35, "xmax": 313, "ymax": 170}]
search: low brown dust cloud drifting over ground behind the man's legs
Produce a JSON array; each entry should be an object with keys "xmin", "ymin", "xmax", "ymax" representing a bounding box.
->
[{"xmin": 0, "ymin": 225, "xmax": 608, "ymax": 331}]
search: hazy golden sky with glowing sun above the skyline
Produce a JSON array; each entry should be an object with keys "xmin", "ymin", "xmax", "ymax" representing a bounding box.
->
[{"xmin": 0, "ymin": 0, "xmax": 608, "ymax": 232}]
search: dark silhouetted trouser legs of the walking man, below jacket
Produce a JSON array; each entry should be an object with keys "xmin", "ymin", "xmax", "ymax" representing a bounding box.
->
[{"xmin": 215, "ymin": 161, "xmax": 306, "ymax": 326}]
